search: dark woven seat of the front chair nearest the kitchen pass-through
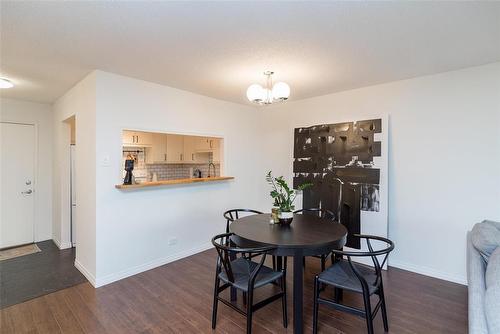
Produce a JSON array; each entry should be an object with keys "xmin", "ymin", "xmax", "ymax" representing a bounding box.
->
[{"xmin": 219, "ymin": 258, "xmax": 283, "ymax": 291}]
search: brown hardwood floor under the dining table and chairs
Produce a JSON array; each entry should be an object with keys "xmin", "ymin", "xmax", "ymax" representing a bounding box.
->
[{"xmin": 0, "ymin": 250, "xmax": 467, "ymax": 334}]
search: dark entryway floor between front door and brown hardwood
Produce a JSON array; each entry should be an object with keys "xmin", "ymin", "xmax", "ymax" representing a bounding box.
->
[{"xmin": 0, "ymin": 240, "xmax": 87, "ymax": 309}]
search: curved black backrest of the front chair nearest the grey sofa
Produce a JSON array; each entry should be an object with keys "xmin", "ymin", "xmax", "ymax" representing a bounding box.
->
[{"xmin": 332, "ymin": 234, "xmax": 394, "ymax": 286}]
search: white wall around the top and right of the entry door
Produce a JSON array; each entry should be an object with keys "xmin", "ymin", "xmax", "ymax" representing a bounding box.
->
[{"xmin": 0, "ymin": 98, "xmax": 52, "ymax": 241}]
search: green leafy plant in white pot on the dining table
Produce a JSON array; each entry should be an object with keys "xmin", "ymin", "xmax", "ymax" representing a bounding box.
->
[{"xmin": 266, "ymin": 171, "xmax": 312, "ymax": 225}]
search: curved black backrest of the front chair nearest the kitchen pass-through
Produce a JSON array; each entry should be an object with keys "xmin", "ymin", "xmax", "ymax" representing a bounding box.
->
[{"xmin": 212, "ymin": 233, "xmax": 276, "ymax": 284}]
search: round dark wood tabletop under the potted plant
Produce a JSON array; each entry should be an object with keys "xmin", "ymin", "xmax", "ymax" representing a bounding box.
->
[{"xmin": 229, "ymin": 214, "xmax": 347, "ymax": 256}]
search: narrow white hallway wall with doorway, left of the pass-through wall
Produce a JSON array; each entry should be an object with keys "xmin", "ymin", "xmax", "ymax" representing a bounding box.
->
[{"xmin": 53, "ymin": 72, "xmax": 96, "ymax": 281}]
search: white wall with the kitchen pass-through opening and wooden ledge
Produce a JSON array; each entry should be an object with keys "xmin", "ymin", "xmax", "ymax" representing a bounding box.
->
[{"xmin": 92, "ymin": 72, "xmax": 267, "ymax": 286}]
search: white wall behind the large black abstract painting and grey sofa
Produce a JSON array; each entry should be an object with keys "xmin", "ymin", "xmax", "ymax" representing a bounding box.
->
[{"xmin": 263, "ymin": 63, "xmax": 500, "ymax": 283}]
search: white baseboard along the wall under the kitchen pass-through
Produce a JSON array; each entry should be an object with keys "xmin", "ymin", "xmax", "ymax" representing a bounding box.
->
[{"xmin": 93, "ymin": 242, "xmax": 213, "ymax": 288}]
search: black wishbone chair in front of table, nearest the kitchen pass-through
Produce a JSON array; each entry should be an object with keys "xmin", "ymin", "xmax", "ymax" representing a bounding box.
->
[{"xmin": 212, "ymin": 233, "xmax": 288, "ymax": 334}]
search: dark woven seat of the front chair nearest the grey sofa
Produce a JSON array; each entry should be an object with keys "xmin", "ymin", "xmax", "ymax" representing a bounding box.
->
[{"xmin": 319, "ymin": 260, "xmax": 377, "ymax": 295}]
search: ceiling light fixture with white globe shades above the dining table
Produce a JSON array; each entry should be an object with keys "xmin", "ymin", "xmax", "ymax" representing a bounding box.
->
[{"xmin": 247, "ymin": 71, "xmax": 290, "ymax": 105}]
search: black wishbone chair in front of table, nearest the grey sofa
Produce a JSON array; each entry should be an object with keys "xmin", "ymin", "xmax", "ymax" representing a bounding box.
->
[{"xmin": 313, "ymin": 234, "xmax": 394, "ymax": 334}]
